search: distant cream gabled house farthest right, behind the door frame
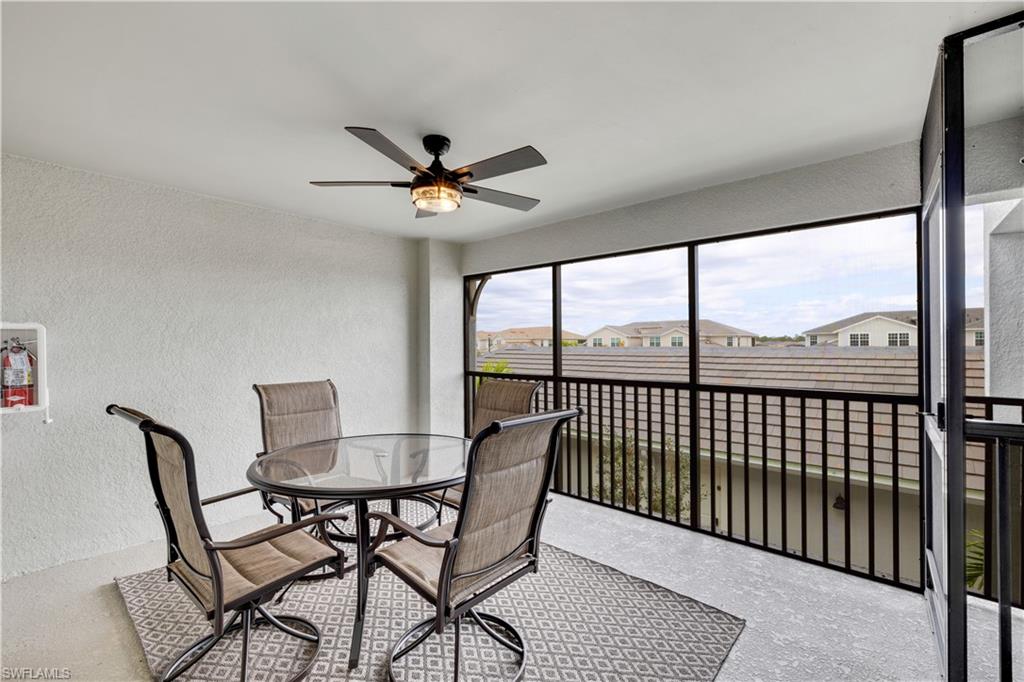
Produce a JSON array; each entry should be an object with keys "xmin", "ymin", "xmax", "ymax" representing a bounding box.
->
[{"xmin": 804, "ymin": 308, "xmax": 985, "ymax": 347}]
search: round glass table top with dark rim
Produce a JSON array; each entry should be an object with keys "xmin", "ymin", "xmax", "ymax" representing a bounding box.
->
[{"xmin": 246, "ymin": 433, "xmax": 470, "ymax": 500}]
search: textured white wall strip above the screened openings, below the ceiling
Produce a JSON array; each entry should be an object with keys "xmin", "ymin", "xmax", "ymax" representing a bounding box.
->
[{"xmin": 462, "ymin": 140, "xmax": 921, "ymax": 274}]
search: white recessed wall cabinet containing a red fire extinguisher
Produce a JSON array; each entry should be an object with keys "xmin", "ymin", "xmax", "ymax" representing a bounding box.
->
[{"xmin": 0, "ymin": 322, "xmax": 52, "ymax": 424}]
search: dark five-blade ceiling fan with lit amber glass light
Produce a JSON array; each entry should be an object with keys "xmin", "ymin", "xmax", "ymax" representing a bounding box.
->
[{"xmin": 309, "ymin": 126, "xmax": 548, "ymax": 218}]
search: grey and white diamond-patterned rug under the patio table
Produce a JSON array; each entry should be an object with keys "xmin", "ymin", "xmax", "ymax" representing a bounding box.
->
[{"xmin": 117, "ymin": 507, "xmax": 743, "ymax": 682}]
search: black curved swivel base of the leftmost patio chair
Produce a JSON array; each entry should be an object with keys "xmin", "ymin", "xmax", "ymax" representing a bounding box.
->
[{"xmin": 160, "ymin": 604, "xmax": 323, "ymax": 682}]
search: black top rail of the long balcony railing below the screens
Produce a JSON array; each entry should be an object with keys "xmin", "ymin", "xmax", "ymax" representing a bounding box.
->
[{"xmin": 466, "ymin": 370, "xmax": 921, "ymax": 406}]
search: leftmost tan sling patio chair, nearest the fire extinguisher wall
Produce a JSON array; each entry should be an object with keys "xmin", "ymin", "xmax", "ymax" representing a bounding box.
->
[{"xmin": 106, "ymin": 404, "xmax": 345, "ymax": 682}]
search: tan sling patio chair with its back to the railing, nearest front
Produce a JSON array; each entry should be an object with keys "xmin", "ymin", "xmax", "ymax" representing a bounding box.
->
[{"xmin": 370, "ymin": 408, "xmax": 583, "ymax": 680}]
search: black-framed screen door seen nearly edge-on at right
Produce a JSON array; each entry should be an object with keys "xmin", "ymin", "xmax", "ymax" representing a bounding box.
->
[{"xmin": 921, "ymin": 30, "xmax": 967, "ymax": 680}]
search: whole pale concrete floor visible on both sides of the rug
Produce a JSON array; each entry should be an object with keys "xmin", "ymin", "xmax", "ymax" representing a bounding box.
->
[{"xmin": 2, "ymin": 496, "xmax": 1024, "ymax": 682}]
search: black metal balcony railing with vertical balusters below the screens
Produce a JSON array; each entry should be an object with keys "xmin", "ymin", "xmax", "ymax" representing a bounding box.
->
[{"xmin": 466, "ymin": 372, "xmax": 1024, "ymax": 603}]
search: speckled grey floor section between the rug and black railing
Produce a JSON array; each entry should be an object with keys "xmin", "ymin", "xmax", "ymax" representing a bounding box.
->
[{"xmin": 544, "ymin": 495, "xmax": 1024, "ymax": 680}]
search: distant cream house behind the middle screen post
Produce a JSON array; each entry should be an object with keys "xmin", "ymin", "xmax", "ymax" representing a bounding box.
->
[{"xmin": 587, "ymin": 319, "xmax": 754, "ymax": 348}]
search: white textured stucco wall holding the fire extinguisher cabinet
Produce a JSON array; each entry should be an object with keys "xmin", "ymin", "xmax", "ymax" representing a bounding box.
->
[{"xmin": 2, "ymin": 157, "xmax": 419, "ymax": 577}]
